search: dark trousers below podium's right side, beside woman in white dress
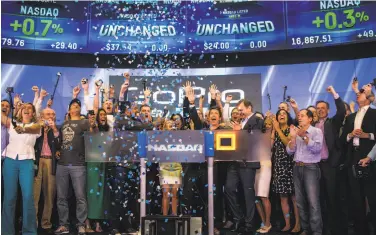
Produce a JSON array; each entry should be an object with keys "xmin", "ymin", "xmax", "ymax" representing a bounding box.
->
[{"xmin": 225, "ymin": 163, "xmax": 256, "ymax": 227}]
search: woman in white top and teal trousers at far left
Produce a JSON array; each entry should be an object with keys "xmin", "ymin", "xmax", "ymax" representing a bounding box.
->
[{"xmin": 1, "ymin": 103, "xmax": 41, "ymax": 235}]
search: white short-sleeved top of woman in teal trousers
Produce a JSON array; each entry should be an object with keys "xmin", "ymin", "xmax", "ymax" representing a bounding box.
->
[{"xmin": 2, "ymin": 123, "xmax": 41, "ymax": 160}]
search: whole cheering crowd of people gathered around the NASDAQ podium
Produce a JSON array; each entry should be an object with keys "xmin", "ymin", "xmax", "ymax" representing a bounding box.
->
[{"xmin": 1, "ymin": 73, "xmax": 376, "ymax": 235}]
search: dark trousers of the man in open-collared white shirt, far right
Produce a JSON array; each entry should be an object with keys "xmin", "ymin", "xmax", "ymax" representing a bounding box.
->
[{"xmin": 348, "ymin": 163, "xmax": 376, "ymax": 235}]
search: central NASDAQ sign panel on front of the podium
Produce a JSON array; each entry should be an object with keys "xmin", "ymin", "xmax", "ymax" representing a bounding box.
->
[{"xmin": 146, "ymin": 130, "xmax": 205, "ymax": 162}]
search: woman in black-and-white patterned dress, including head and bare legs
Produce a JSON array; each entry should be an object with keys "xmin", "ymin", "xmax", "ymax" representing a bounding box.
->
[{"xmin": 271, "ymin": 109, "xmax": 300, "ymax": 233}]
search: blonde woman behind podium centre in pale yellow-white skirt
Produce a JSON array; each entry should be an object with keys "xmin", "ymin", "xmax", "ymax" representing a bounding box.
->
[{"xmin": 159, "ymin": 120, "xmax": 182, "ymax": 215}]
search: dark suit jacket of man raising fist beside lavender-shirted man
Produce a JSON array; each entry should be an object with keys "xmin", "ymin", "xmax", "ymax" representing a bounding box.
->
[{"xmin": 324, "ymin": 98, "xmax": 346, "ymax": 167}]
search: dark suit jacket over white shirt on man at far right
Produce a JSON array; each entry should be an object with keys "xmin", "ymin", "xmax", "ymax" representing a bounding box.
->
[{"xmin": 341, "ymin": 108, "xmax": 376, "ymax": 165}]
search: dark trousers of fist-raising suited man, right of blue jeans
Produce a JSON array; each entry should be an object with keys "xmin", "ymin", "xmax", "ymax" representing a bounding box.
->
[{"xmin": 319, "ymin": 161, "xmax": 340, "ymax": 235}]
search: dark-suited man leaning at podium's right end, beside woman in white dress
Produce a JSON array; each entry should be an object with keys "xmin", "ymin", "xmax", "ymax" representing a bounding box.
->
[{"xmin": 225, "ymin": 99, "xmax": 264, "ymax": 232}]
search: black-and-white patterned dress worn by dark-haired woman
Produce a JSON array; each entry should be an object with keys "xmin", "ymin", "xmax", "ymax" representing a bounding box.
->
[{"xmin": 272, "ymin": 128, "xmax": 294, "ymax": 194}]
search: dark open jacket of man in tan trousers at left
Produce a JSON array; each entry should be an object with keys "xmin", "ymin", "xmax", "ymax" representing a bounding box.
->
[{"xmin": 34, "ymin": 128, "xmax": 62, "ymax": 175}]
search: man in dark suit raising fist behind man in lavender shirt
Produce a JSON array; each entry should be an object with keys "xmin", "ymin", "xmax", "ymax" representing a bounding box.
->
[{"xmin": 315, "ymin": 86, "xmax": 346, "ymax": 235}]
